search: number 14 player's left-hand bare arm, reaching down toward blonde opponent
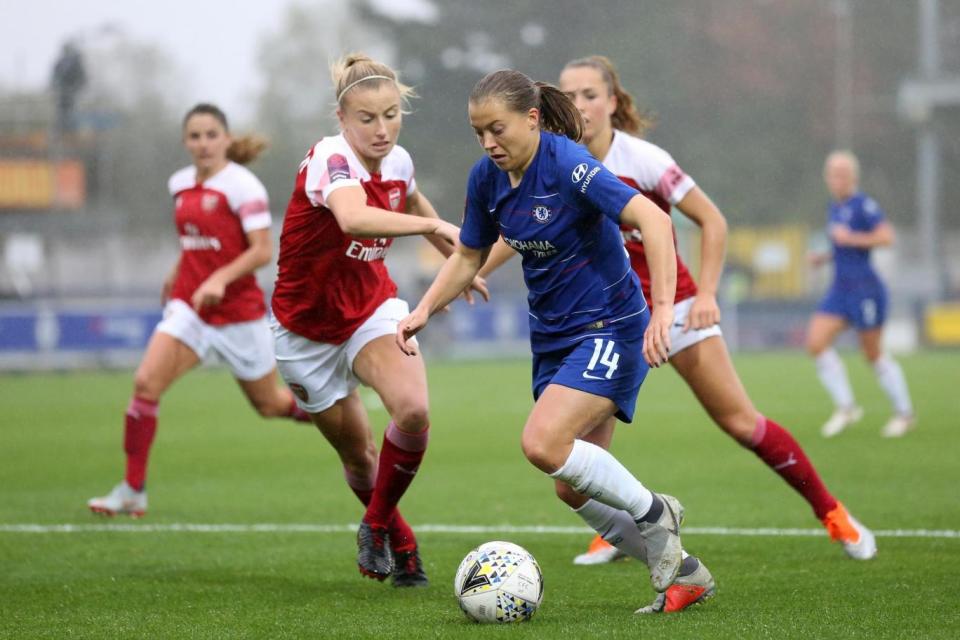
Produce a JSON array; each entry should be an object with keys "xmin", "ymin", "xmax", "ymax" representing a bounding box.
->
[{"xmin": 397, "ymin": 243, "xmax": 489, "ymax": 356}]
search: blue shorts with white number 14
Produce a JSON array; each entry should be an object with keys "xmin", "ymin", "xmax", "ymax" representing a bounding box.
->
[{"xmin": 533, "ymin": 330, "xmax": 650, "ymax": 422}]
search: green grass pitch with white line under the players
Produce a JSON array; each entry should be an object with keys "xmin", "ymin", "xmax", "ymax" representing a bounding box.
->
[{"xmin": 0, "ymin": 352, "xmax": 960, "ymax": 639}]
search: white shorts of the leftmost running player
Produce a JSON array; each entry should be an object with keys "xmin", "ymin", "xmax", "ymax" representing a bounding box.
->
[{"xmin": 155, "ymin": 300, "xmax": 277, "ymax": 380}]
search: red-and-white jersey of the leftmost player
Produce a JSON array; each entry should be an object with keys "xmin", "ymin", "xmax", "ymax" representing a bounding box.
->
[{"xmin": 168, "ymin": 162, "xmax": 271, "ymax": 325}]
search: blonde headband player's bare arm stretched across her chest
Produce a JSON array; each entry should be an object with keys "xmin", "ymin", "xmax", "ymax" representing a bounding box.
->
[{"xmin": 327, "ymin": 187, "xmax": 460, "ymax": 244}]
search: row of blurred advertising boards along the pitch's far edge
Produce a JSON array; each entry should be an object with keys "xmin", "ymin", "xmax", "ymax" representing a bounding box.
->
[{"xmin": 0, "ymin": 294, "xmax": 960, "ymax": 371}]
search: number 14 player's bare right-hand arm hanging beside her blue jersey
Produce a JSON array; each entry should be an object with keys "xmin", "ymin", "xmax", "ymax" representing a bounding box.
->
[{"xmin": 620, "ymin": 194, "xmax": 677, "ymax": 367}]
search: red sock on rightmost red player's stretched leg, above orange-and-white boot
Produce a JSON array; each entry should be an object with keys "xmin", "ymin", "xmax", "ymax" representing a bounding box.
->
[{"xmin": 751, "ymin": 416, "xmax": 837, "ymax": 520}]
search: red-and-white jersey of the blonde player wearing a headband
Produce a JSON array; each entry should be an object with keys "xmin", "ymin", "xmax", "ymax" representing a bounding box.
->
[{"xmin": 271, "ymin": 134, "xmax": 416, "ymax": 344}]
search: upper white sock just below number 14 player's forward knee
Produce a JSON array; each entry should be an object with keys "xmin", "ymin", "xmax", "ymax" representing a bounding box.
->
[{"xmin": 550, "ymin": 440, "xmax": 653, "ymax": 520}]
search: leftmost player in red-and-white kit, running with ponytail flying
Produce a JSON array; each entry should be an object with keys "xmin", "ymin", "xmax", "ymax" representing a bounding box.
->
[{"xmin": 87, "ymin": 104, "xmax": 308, "ymax": 517}]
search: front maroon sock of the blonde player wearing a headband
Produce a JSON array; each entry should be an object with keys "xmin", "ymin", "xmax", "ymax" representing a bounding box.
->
[{"xmin": 363, "ymin": 420, "xmax": 430, "ymax": 527}]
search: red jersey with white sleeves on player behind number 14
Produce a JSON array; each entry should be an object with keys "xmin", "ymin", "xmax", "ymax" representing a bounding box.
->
[{"xmin": 603, "ymin": 131, "xmax": 697, "ymax": 306}]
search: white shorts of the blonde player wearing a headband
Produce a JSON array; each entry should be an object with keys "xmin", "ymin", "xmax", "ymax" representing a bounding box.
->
[{"xmin": 270, "ymin": 298, "xmax": 416, "ymax": 413}]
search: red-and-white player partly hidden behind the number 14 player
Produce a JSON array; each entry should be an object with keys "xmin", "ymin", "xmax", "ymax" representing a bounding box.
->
[{"xmin": 480, "ymin": 56, "xmax": 876, "ymax": 611}]
